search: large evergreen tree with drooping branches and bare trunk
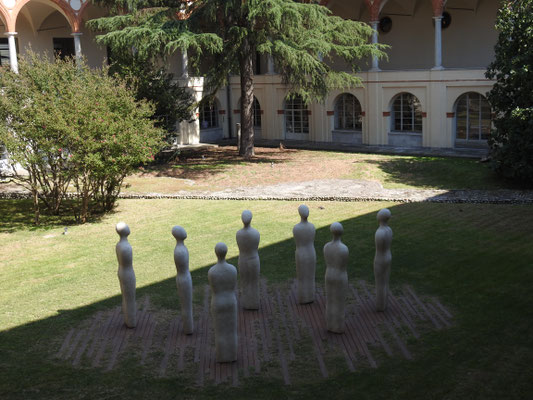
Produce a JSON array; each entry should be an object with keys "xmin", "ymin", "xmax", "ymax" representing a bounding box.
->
[{"xmin": 89, "ymin": 0, "xmax": 382, "ymax": 158}]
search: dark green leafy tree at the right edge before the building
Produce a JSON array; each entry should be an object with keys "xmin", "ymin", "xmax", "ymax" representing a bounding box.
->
[{"xmin": 486, "ymin": 0, "xmax": 533, "ymax": 185}]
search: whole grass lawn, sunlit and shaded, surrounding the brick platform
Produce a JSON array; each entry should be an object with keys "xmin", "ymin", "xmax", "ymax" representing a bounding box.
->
[{"xmin": 0, "ymin": 200, "xmax": 533, "ymax": 399}]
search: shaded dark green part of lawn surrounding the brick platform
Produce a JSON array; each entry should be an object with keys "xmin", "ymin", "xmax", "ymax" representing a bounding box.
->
[{"xmin": 0, "ymin": 204, "xmax": 533, "ymax": 399}]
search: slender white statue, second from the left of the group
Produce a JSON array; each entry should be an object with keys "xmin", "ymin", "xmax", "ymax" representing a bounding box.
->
[{"xmin": 172, "ymin": 226, "xmax": 194, "ymax": 335}]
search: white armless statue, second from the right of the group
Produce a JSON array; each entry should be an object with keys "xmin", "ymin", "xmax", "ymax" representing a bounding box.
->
[{"xmin": 324, "ymin": 222, "xmax": 349, "ymax": 333}]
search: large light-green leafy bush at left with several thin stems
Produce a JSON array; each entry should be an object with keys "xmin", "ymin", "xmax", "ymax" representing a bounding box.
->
[{"xmin": 0, "ymin": 54, "xmax": 163, "ymax": 222}]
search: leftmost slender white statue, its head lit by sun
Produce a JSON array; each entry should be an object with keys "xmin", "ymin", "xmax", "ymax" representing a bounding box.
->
[{"xmin": 115, "ymin": 222, "xmax": 137, "ymax": 328}]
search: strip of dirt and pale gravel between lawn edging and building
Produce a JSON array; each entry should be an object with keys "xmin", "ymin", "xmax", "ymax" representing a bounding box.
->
[{"xmin": 0, "ymin": 146, "xmax": 533, "ymax": 204}]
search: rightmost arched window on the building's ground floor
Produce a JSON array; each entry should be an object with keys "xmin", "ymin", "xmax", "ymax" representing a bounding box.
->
[{"xmin": 455, "ymin": 92, "xmax": 491, "ymax": 140}]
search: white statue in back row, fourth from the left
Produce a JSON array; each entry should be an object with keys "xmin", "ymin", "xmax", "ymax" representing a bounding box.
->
[{"xmin": 237, "ymin": 210, "xmax": 260, "ymax": 310}]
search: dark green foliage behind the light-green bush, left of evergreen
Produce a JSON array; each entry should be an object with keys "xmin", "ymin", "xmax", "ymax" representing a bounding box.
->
[{"xmin": 109, "ymin": 50, "xmax": 194, "ymax": 133}]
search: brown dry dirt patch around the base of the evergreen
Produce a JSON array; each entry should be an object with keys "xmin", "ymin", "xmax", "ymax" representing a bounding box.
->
[{"xmin": 127, "ymin": 146, "xmax": 351, "ymax": 193}]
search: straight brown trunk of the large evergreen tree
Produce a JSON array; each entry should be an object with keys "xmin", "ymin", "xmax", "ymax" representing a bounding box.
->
[{"xmin": 239, "ymin": 39, "xmax": 254, "ymax": 159}]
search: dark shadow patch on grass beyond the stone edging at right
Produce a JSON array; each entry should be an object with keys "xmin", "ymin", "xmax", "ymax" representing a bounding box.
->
[{"xmin": 355, "ymin": 156, "xmax": 519, "ymax": 190}]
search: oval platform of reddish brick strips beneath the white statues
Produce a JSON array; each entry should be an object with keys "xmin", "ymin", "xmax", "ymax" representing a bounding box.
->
[{"xmin": 56, "ymin": 281, "xmax": 452, "ymax": 386}]
